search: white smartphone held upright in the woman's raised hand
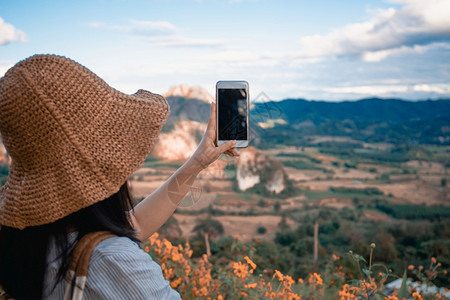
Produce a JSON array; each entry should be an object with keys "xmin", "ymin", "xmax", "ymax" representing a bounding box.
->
[{"xmin": 216, "ymin": 81, "xmax": 250, "ymax": 148}]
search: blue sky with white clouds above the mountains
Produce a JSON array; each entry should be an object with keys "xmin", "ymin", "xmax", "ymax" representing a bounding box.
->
[{"xmin": 0, "ymin": 0, "xmax": 450, "ymax": 101}]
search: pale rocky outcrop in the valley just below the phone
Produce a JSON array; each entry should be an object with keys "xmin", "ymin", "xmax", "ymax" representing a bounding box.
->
[{"xmin": 236, "ymin": 147, "xmax": 287, "ymax": 194}]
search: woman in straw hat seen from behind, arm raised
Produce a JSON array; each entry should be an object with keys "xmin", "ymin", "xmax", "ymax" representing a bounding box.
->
[{"xmin": 0, "ymin": 55, "xmax": 238, "ymax": 299}]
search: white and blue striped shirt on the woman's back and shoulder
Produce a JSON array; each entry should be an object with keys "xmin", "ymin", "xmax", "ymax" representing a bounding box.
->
[{"xmin": 44, "ymin": 237, "xmax": 181, "ymax": 300}]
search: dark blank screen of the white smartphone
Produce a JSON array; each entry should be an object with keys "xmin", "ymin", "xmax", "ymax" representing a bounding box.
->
[{"xmin": 217, "ymin": 89, "xmax": 247, "ymax": 141}]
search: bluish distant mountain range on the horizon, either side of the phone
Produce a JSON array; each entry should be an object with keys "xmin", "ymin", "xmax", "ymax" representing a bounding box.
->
[{"xmin": 163, "ymin": 96, "xmax": 450, "ymax": 147}]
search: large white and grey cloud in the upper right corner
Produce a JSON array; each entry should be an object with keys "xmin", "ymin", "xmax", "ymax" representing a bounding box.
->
[{"xmin": 299, "ymin": 0, "xmax": 450, "ymax": 61}]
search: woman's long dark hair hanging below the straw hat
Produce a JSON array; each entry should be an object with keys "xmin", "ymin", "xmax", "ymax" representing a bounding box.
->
[{"xmin": 0, "ymin": 182, "xmax": 137, "ymax": 300}]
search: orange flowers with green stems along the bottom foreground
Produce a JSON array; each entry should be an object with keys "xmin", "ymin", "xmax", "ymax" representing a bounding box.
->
[{"xmin": 142, "ymin": 233, "xmax": 446, "ymax": 300}]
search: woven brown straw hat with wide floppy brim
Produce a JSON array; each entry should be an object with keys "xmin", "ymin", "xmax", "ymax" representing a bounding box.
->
[{"xmin": 0, "ymin": 55, "xmax": 169, "ymax": 229}]
